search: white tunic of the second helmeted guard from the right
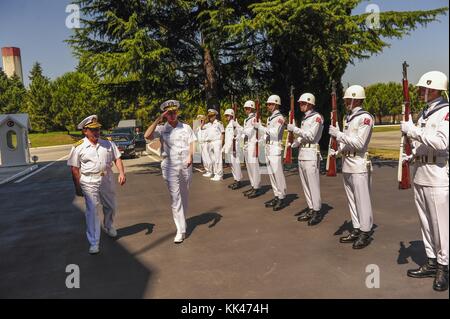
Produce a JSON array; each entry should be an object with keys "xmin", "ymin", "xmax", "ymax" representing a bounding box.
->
[{"xmin": 337, "ymin": 107, "xmax": 374, "ymax": 174}]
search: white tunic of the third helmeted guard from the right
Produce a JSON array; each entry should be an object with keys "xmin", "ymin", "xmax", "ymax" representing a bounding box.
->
[{"xmin": 294, "ymin": 110, "xmax": 323, "ymax": 161}]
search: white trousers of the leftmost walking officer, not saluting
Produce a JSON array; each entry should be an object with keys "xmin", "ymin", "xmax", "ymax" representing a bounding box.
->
[{"xmin": 80, "ymin": 172, "xmax": 117, "ymax": 246}]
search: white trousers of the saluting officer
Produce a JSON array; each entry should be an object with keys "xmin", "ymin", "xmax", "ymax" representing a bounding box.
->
[{"xmin": 161, "ymin": 159, "xmax": 192, "ymax": 234}]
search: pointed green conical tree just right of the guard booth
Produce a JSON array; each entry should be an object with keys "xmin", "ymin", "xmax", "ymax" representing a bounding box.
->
[{"xmin": 26, "ymin": 62, "xmax": 54, "ymax": 132}]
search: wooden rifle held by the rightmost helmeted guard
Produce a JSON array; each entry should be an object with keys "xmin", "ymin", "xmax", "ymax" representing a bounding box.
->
[{"xmin": 397, "ymin": 61, "xmax": 412, "ymax": 189}]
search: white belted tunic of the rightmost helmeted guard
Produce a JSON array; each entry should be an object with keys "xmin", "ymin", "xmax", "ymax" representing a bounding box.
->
[{"xmin": 408, "ymin": 98, "xmax": 449, "ymax": 187}]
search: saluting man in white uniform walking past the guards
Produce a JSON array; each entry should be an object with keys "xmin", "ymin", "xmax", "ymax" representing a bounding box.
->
[{"xmin": 145, "ymin": 100, "xmax": 196, "ymax": 244}]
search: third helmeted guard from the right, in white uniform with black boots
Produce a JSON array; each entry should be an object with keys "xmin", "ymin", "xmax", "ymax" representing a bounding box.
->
[{"xmin": 287, "ymin": 93, "xmax": 323, "ymax": 226}]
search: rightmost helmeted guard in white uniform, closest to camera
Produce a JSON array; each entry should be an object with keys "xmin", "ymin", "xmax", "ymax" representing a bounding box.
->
[{"xmin": 401, "ymin": 71, "xmax": 449, "ymax": 291}]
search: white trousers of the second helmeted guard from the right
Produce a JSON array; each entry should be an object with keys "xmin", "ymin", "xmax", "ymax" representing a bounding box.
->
[{"xmin": 343, "ymin": 173, "xmax": 373, "ymax": 232}]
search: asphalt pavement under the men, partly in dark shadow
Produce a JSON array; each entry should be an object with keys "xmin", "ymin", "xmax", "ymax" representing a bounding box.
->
[{"xmin": 0, "ymin": 150, "xmax": 449, "ymax": 299}]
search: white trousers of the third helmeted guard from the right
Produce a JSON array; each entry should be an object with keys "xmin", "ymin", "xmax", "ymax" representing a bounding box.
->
[{"xmin": 298, "ymin": 160, "xmax": 322, "ymax": 211}]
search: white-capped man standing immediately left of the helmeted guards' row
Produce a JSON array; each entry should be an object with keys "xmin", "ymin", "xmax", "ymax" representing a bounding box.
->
[{"xmin": 202, "ymin": 109, "xmax": 225, "ymax": 182}]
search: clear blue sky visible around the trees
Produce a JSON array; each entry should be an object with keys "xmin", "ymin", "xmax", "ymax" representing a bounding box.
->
[{"xmin": 0, "ymin": 0, "xmax": 449, "ymax": 85}]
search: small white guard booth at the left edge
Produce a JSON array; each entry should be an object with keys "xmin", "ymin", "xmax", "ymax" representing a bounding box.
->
[{"xmin": 0, "ymin": 114, "xmax": 31, "ymax": 167}]
